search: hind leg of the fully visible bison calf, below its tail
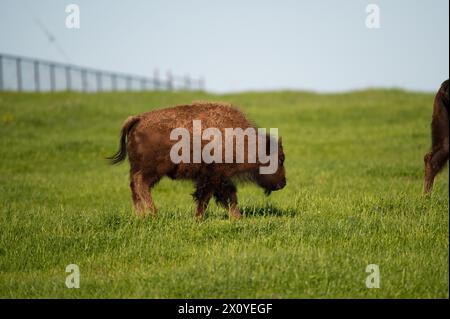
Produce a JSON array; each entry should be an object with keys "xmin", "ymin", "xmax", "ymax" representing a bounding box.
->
[{"xmin": 130, "ymin": 172, "xmax": 156, "ymax": 216}]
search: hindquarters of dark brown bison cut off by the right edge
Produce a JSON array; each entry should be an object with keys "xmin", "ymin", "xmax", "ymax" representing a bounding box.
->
[{"xmin": 423, "ymin": 80, "xmax": 449, "ymax": 194}]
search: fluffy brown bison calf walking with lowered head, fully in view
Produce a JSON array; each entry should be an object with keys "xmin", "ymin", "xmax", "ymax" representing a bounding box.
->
[{"xmin": 110, "ymin": 102, "xmax": 286, "ymax": 218}]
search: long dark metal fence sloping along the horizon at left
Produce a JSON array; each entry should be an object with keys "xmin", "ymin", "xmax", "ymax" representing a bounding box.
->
[{"xmin": 0, "ymin": 53, "xmax": 205, "ymax": 92}]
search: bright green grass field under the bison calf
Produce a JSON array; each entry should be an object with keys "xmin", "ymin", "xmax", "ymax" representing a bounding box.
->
[{"xmin": 0, "ymin": 90, "xmax": 449, "ymax": 298}]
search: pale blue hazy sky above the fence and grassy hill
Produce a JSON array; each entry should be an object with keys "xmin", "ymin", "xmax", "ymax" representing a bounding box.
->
[{"xmin": 0, "ymin": 0, "xmax": 449, "ymax": 93}]
